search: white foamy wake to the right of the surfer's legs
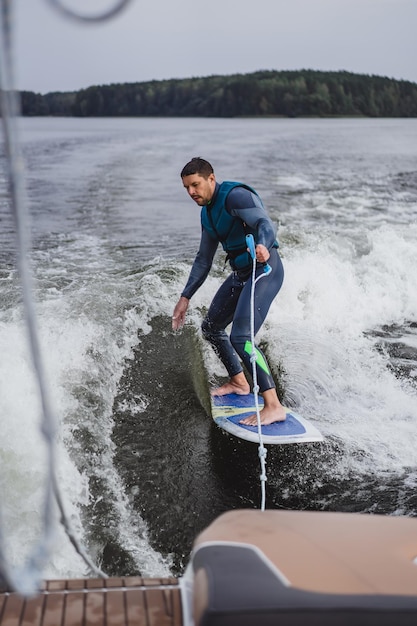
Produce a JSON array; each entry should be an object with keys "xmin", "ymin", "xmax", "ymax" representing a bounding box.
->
[{"xmin": 264, "ymin": 226, "xmax": 417, "ymax": 470}]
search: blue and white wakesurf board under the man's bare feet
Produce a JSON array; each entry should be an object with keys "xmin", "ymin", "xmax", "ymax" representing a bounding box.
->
[{"xmin": 211, "ymin": 393, "xmax": 324, "ymax": 444}]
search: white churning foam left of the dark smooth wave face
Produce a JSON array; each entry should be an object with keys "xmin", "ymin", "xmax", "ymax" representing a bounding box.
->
[{"xmin": 0, "ymin": 252, "xmax": 170, "ymax": 578}]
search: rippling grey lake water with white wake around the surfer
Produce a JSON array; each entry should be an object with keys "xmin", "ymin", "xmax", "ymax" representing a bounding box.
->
[{"xmin": 0, "ymin": 118, "xmax": 417, "ymax": 578}]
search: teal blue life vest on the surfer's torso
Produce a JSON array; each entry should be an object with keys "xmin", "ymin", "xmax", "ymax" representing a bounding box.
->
[{"xmin": 201, "ymin": 181, "xmax": 258, "ymax": 270}]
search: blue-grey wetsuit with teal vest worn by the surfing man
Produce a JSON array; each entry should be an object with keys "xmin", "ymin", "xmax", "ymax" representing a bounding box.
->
[{"xmin": 181, "ymin": 181, "xmax": 284, "ymax": 392}]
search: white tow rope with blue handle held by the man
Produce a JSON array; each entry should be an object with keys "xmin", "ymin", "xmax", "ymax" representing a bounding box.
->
[{"xmin": 246, "ymin": 235, "xmax": 271, "ymax": 511}]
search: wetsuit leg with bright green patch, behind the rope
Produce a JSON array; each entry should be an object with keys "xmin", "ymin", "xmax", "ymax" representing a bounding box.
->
[{"xmin": 230, "ymin": 250, "xmax": 284, "ymax": 392}]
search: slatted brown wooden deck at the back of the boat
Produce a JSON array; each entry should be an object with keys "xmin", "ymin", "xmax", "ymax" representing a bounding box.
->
[{"xmin": 0, "ymin": 577, "xmax": 182, "ymax": 626}]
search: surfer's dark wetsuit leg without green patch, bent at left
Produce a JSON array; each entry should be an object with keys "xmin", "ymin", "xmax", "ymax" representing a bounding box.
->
[{"xmin": 201, "ymin": 272, "xmax": 245, "ymax": 376}]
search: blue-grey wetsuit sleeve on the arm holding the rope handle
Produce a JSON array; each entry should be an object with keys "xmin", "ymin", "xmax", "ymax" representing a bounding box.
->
[{"xmin": 226, "ymin": 187, "xmax": 277, "ymax": 250}]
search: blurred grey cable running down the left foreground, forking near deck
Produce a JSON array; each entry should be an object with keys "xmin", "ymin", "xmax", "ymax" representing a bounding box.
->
[{"xmin": 0, "ymin": 0, "xmax": 107, "ymax": 596}]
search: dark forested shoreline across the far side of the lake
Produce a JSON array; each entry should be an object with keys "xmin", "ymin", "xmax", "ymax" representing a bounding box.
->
[{"xmin": 21, "ymin": 70, "xmax": 417, "ymax": 117}]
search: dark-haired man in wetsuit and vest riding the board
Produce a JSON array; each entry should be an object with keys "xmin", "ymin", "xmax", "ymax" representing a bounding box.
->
[{"xmin": 172, "ymin": 157, "xmax": 285, "ymax": 426}]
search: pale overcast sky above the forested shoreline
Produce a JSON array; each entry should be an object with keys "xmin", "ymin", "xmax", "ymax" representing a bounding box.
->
[{"xmin": 12, "ymin": 0, "xmax": 417, "ymax": 93}]
